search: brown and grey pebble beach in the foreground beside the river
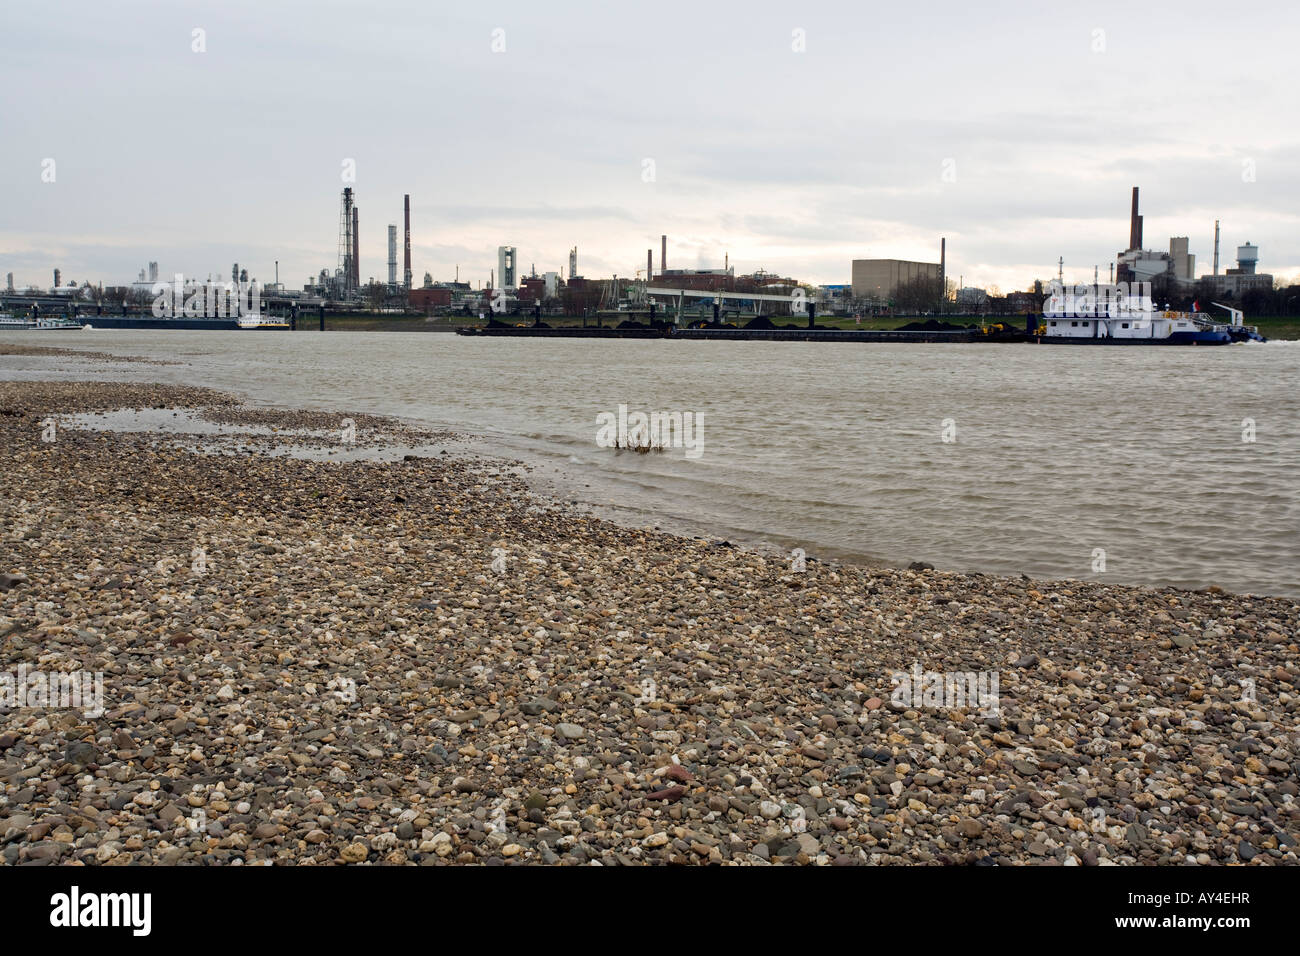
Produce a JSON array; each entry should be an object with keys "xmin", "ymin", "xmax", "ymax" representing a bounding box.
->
[{"xmin": 0, "ymin": 371, "xmax": 1300, "ymax": 866}]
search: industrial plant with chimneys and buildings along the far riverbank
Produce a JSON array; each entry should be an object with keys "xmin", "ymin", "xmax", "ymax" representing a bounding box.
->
[{"xmin": 0, "ymin": 186, "xmax": 1289, "ymax": 324}]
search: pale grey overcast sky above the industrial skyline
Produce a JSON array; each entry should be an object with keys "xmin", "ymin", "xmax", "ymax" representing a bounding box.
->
[{"xmin": 0, "ymin": 0, "xmax": 1300, "ymax": 291}]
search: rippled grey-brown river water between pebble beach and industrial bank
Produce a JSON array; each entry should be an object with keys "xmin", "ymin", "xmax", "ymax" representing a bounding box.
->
[{"xmin": 0, "ymin": 330, "xmax": 1300, "ymax": 596}]
